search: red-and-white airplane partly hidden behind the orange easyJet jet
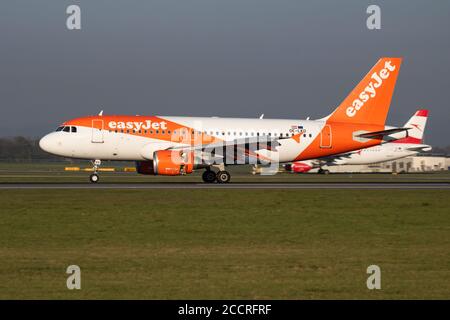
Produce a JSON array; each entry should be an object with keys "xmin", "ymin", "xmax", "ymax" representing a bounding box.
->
[{"xmin": 284, "ymin": 110, "xmax": 431, "ymax": 173}]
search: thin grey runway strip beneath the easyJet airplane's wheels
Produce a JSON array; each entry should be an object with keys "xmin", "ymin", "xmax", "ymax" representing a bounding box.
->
[{"xmin": 0, "ymin": 182, "xmax": 450, "ymax": 190}]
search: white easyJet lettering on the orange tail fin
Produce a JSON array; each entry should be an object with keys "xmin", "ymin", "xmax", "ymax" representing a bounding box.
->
[{"xmin": 346, "ymin": 61, "xmax": 396, "ymax": 117}]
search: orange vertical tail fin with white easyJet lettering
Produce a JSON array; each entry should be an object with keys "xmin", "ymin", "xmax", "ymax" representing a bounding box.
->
[{"xmin": 326, "ymin": 58, "xmax": 402, "ymax": 126}]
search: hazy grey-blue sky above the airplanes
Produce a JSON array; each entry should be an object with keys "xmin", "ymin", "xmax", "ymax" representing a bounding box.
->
[{"xmin": 0, "ymin": 0, "xmax": 450, "ymax": 146}]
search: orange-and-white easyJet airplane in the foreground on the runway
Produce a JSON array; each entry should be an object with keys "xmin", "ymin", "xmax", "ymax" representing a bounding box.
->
[{"xmin": 39, "ymin": 58, "xmax": 407, "ymax": 183}]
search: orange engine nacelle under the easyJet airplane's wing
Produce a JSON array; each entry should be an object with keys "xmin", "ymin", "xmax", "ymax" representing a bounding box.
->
[{"xmin": 153, "ymin": 150, "xmax": 194, "ymax": 176}]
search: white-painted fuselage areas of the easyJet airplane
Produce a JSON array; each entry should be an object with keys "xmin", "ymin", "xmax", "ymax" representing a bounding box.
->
[{"xmin": 41, "ymin": 117, "xmax": 332, "ymax": 162}]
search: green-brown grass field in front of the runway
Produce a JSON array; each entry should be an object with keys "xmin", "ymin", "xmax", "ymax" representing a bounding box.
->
[{"xmin": 0, "ymin": 189, "xmax": 450, "ymax": 299}]
